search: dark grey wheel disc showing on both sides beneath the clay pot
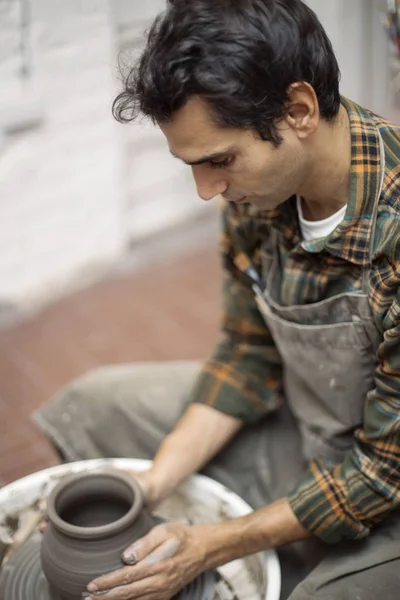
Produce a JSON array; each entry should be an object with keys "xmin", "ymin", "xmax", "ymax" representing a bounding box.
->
[{"xmin": 0, "ymin": 533, "xmax": 215, "ymax": 600}]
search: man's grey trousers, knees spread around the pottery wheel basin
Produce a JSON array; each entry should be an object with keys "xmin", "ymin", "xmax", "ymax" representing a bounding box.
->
[{"xmin": 34, "ymin": 362, "xmax": 400, "ymax": 600}]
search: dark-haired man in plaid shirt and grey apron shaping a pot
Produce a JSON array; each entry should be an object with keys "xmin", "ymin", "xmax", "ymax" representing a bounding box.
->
[{"xmin": 36, "ymin": 0, "xmax": 400, "ymax": 600}]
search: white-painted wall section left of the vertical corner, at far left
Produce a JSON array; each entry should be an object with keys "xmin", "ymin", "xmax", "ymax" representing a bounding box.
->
[{"xmin": 0, "ymin": 0, "xmax": 125, "ymax": 314}]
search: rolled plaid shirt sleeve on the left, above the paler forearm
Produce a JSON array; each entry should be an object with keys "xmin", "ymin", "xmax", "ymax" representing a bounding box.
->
[{"xmin": 191, "ymin": 205, "xmax": 282, "ymax": 423}]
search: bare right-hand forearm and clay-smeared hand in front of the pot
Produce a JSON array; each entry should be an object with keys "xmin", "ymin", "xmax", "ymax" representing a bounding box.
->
[{"xmin": 85, "ymin": 498, "xmax": 311, "ymax": 600}]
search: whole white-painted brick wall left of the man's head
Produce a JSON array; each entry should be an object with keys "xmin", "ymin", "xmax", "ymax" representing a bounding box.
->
[{"xmin": 0, "ymin": 0, "xmax": 203, "ymax": 317}]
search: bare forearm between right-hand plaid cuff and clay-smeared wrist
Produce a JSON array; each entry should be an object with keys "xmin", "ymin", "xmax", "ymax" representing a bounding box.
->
[{"xmin": 200, "ymin": 499, "xmax": 311, "ymax": 569}]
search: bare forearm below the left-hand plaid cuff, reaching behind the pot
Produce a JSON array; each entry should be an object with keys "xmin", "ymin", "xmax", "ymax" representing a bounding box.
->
[{"xmin": 151, "ymin": 404, "xmax": 243, "ymax": 499}]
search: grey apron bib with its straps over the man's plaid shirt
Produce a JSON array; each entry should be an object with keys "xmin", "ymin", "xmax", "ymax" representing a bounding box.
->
[{"xmin": 254, "ymin": 136, "xmax": 385, "ymax": 472}]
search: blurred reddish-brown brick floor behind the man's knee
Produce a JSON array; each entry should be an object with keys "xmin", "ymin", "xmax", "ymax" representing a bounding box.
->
[{"xmin": 0, "ymin": 247, "xmax": 220, "ymax": 484}]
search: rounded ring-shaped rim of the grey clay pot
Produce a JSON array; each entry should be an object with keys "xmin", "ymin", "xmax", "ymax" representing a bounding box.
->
[{"xmin": 47, "ymin": 469, "xmax": 143, "ymax": 539}]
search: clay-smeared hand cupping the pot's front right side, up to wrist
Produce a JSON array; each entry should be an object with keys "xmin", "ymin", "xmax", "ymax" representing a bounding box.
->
[{"xmin": 87, "ymin": 523, "xmax": 209, "ymax": 600}]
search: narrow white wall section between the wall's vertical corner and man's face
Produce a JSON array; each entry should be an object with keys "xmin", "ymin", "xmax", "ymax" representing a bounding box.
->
[{"xmin": 113, "ymin": 0, "xmax": 209, "ymax": 243}]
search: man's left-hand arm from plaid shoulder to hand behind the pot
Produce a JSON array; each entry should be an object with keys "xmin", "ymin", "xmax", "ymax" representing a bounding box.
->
[{"xmin": 139, "ymin": 203, "xmax": 282, "ymax": 503}]
